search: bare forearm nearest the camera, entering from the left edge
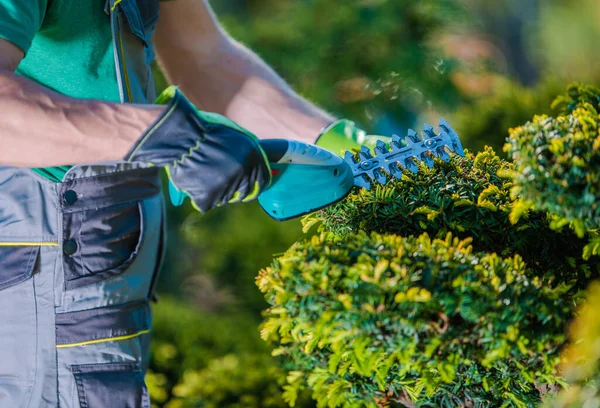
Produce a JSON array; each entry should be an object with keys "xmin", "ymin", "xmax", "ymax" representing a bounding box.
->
[{"xmin": 0, "ymin": 70, "xmax": 164, "ymax": 167}]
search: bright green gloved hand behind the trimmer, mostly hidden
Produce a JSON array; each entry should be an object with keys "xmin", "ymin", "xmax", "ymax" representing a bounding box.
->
[{"xmin": 315, "ymin": 119, "xmax": 392, "ymax": 154}]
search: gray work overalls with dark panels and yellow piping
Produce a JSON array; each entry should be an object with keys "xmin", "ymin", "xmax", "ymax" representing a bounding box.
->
[{"xmin": 0, "ymin": 0, "xmax": 164, "ymax": 408}]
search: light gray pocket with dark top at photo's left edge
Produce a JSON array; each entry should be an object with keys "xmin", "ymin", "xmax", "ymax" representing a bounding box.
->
[{"xmin": 0, "ymin": 243, "xmax": 40, "ymax": 407}]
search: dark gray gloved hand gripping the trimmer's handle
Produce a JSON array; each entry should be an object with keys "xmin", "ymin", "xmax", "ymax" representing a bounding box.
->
[{"xmin": 125, "ymin": 87, "xmax": 271, "ymax": 212}]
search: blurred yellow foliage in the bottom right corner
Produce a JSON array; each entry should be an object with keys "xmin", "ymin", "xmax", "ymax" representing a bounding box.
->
[{"xmin": 547, "ymin": 282, "xmax": 600, "ymax": 408}]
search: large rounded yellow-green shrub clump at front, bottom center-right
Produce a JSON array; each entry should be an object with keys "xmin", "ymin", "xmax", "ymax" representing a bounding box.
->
[{"xmin": 258, "ymin": 233, "xmax": 570, "ymax": 407}]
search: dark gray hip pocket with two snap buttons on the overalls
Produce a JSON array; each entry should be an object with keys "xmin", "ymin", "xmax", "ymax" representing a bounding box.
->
[{"xmin": 61, "ymin": 168, "xmax": 160, "ymax": 290}]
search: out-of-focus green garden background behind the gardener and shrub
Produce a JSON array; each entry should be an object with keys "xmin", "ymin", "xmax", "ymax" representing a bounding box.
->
[{"xmin": 147, "ymin": 0, "xmax": 600, "ymax": 408}]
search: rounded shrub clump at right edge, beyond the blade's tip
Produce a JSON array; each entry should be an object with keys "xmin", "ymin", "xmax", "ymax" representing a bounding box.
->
[{"xmin": 505, "ymin": 86, "xmax": 600, "ymax": 258}]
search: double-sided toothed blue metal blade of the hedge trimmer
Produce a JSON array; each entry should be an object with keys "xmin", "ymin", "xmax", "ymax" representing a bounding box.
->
[{"xmin": 344, "ymin": 119, "xmax": 465, "ymax": 190}]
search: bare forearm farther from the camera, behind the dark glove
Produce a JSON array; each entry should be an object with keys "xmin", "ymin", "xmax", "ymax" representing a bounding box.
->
[{"xmin": 155, "ymin": 37, "xmax": 334, "ymax": 143}]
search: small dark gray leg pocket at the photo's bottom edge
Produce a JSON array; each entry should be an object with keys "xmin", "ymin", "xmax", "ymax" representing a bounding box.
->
[{"xmin": 71, "ymin": 363, "xmax": 150, "ymax": 408}]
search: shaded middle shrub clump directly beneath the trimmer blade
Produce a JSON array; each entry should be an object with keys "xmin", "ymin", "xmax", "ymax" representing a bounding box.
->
[{"xmin": 305, "ymin": 148, "xmax": 598, "ymax": 283}]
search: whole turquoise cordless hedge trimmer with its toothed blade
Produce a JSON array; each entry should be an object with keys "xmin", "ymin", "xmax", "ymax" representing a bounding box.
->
[{"xmin": 258, "ymin": 119, "xmax": 464, "ymax": 221}]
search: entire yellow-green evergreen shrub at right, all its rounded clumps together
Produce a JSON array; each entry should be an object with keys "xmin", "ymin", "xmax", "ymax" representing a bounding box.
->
[{"xmin": 257, "ymin": 87, "xmax": 600, "ymax": 408}]
